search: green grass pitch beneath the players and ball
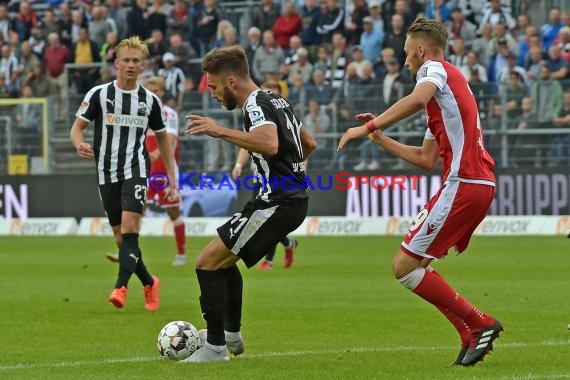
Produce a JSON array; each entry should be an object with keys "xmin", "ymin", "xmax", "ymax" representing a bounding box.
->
[{"xmin": 0, "ymin": 236, "xmax": 570, "ymax": 380}]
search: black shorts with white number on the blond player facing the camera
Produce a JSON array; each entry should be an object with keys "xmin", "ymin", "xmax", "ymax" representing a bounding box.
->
[{"xmin": 99, "ymin": 178, "xmax": 148, "ymax": 227}]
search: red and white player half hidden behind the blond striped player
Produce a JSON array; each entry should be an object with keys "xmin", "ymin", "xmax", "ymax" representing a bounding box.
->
[{"xmin": 107, "ymin": 76, "xmax": 187, "ymax": 266}]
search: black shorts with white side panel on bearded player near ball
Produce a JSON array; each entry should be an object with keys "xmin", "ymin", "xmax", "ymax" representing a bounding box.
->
[{"xmin": 218, "ymin": 199, "xmax": 309, "ymax": 268}]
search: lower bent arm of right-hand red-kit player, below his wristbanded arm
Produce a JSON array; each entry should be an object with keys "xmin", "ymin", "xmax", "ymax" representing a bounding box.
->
[{"xmin": 368, "ymin": 131, "xmax": 439, "ymax": 171}]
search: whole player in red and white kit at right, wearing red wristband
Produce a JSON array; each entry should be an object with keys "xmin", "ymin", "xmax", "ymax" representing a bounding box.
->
[{"xmin": 338, "ymin": 17, "xmax": 503, "ymax": 366}]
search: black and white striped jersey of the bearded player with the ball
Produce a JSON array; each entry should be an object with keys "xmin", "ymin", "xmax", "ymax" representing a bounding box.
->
[{"xmin": 242, "ymin": 90, "xmax": 307, "ymax": 201}]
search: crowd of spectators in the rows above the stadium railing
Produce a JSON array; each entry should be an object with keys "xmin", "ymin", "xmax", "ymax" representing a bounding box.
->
[{"xmin": 0, "ymin": 0, "xmax": 570, "ymax": 169}]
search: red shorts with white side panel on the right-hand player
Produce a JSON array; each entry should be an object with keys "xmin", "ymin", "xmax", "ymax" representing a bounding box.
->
[{"xmin": 401, "ymin": 181, "xmax": 495, "ymax": 259}]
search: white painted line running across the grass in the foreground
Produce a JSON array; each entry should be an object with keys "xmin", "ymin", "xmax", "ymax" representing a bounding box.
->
[{"xmin": 0, "ymin": 340, "xmax": 570, "ymax": 372}]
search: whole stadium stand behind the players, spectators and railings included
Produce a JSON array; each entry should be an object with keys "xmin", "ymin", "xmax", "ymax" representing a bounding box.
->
[{"xmin": 0, "ymin": 0, "xmax": 570, "ymax": 174}]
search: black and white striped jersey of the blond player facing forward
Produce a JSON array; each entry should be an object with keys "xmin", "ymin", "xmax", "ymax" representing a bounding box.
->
[{"xmin": 75, "ymin": 81, "xmax": 166, "ymax": 185}]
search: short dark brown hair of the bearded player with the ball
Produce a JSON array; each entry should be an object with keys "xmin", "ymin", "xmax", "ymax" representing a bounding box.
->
[{"xmin": 202, "ymin": 45, "xmax": 249, "ymax": 78}]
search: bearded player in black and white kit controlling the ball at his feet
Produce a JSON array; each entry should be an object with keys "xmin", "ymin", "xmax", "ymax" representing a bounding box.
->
[{"xmin": 179, "ymin": 46, "xmax": 316, "ymax": 363}]
